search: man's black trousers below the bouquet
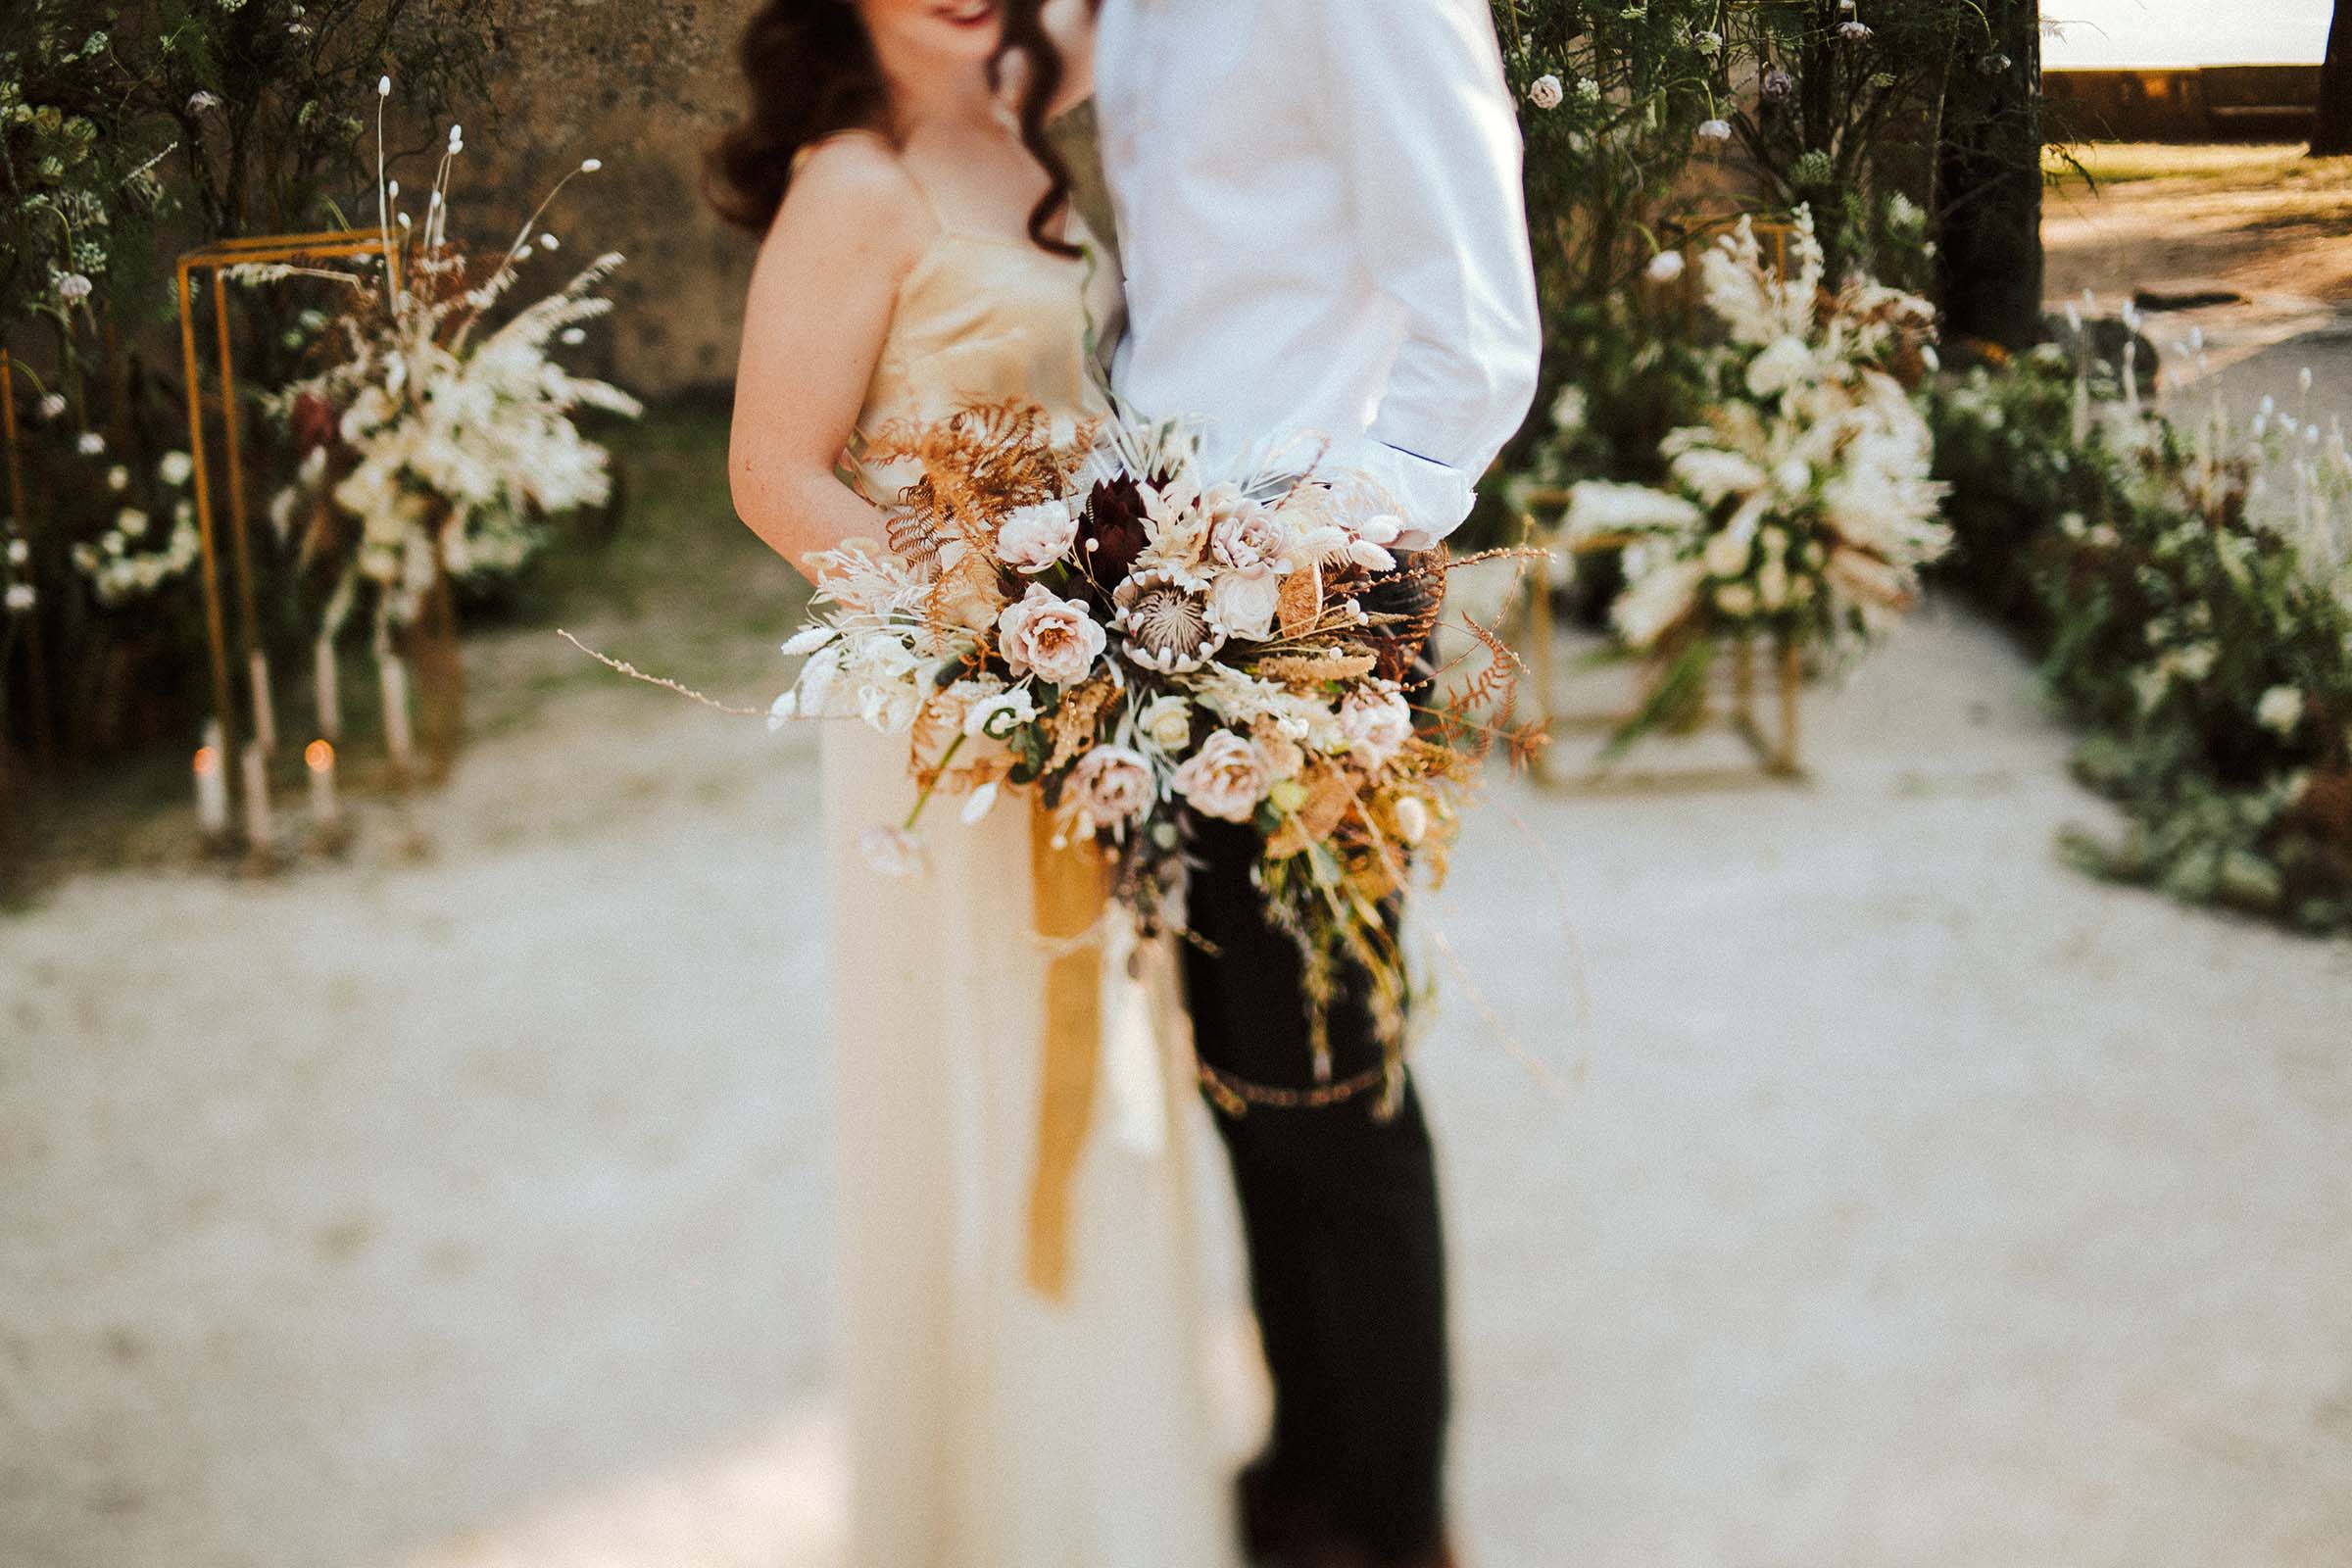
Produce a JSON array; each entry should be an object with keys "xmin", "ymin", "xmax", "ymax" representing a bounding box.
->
[{"xmin": 1186, "ymin": 823, "xmax": 1448, "ymax": 1561}]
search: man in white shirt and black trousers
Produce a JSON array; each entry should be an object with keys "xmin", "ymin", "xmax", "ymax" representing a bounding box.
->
[{"xmin": 1096, "ymin": 0, "xmax": 1539, "ymax": 1568}]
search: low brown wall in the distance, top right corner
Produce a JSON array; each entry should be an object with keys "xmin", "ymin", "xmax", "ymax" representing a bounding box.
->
[{"xmin": 2041, "ymin": 66, "xmax": 2319, "ymax": 141}]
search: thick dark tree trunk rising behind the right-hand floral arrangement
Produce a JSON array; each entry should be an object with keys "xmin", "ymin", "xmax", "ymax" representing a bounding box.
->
[{"xmin": 1936, "ymin": 0, "xmax": 2041, "ymax": 353}]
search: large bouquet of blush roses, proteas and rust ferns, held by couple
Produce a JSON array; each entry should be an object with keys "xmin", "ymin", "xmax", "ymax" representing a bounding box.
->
[{"xmin": 771, "ymin": 405, "xmax": 1529, "ymax": 1072}]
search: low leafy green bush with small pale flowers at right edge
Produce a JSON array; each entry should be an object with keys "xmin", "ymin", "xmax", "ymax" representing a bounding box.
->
[{"xmin": 1934, "ymin": 343, "xmax": 2352, "ymax": 931}]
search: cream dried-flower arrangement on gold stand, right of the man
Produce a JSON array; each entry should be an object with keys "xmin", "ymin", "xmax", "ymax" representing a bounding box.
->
[{"xmin": 1559, "ymin": 207, "xmax": 1950, "ymax": 743}]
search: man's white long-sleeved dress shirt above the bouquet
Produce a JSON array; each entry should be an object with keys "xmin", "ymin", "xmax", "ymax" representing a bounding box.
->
[{"xmin": 1096, "ymin": 0, "xmax": 1541, "ymax": 543}]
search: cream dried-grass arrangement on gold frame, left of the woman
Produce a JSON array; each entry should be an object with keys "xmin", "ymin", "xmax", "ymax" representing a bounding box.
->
[{"xmin": 235, "ymin": 80, "xmax": 642, "ymax": 766}]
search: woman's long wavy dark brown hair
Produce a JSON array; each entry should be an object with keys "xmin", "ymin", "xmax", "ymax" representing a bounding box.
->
[{"xmin": 704, "ymin": 0, "xmax": 1077, "ymax": 256}]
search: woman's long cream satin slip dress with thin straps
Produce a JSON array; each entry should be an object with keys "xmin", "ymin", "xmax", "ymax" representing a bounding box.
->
[{"xmin": 823, "ymin": 134, "xmax": 1235, "ymax": 1568}]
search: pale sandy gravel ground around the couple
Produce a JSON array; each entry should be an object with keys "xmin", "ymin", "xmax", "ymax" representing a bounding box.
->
[{"xmin": 0, "ymin": 594, "xmax": 2352, "ymax": 1568}]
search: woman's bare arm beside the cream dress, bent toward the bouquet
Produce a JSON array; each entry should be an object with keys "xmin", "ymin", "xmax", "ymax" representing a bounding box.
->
[{"xmin": 727, "ymin": 136, "xmax": 931, "ymax": 580}]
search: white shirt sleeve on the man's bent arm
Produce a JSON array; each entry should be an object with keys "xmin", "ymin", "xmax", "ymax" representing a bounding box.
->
[{"xmin": 1289, "ymin": 0, "xmax": 1543, "ymax": 538}]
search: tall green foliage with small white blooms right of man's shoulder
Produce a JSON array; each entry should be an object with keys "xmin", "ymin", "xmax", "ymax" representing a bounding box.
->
[{"xmin": 1494, "ymin": 0, "xmax": 1989, "ymax": 512}]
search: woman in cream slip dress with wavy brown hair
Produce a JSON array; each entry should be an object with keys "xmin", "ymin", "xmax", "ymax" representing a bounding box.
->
[{"xmin": 712, "ymin": 0, "xmax": 1233, "ymax": 1568}]
